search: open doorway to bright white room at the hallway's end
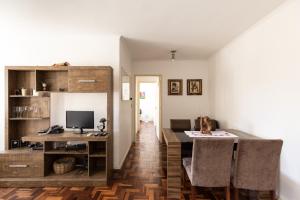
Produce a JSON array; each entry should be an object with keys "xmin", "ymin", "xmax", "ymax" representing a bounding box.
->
[{"xmin": 134, "ymin": 75, "xmax": 162, "ymax": 142}]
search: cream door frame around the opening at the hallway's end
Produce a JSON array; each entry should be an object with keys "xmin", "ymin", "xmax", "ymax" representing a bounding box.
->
[{"xmin": 133, "ymin": 74, "xmax": 163, "ymax": 142}]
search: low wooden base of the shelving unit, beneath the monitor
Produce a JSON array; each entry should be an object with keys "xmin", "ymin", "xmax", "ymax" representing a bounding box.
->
[{"xmin": 0, "ymin": 131, "xmax": 112, "ymax": 187}]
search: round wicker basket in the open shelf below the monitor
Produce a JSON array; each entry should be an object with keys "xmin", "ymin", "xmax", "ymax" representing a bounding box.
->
[{"xmin": 53, "ymin": 157, "xmax": 75, "ymax": 174}]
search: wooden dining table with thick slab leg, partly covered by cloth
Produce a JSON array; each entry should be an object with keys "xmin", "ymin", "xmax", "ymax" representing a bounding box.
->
[{"xmin": 163, "ymin": 128, "xmax": 258, "ymax": 199}]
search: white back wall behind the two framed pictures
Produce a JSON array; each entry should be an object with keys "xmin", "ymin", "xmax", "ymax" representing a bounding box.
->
[{"xmin": 133, "ymin": 60, "xmax": 209, "ymax": 128}]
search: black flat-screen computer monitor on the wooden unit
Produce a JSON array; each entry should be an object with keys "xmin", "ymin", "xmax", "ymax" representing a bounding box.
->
[{"xmin": 66, "ymin": 111, "xmax": 94, "ymax": 134}]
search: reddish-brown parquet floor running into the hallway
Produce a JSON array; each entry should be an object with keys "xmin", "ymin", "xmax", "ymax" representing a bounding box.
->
[{"xmin": 0, "ymin": 123, "xmax": 276, "ymax": 200}]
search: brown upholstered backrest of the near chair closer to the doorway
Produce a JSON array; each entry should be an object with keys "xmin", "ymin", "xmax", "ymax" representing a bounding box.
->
[{"xmin": 191, "ymin": 138, "xmax": 234, "ymax": 187}]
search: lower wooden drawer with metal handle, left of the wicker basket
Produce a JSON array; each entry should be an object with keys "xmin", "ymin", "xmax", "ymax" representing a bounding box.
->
[{"xmin": 0, "ymin": 153, "xmax": 44, "ymax": 178}]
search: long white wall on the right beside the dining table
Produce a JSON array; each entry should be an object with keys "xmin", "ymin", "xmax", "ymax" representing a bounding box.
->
[{"xmin": 210, "ymin": 0, "xmax": 300, "ymax": 200}]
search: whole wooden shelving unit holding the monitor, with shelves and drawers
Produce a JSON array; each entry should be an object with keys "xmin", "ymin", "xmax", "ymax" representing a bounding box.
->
[{"xmin": 0, "ymin": 66, "xmax": 113, "ymax": 187}]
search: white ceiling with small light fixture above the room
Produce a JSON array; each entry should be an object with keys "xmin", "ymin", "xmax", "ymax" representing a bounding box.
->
[{"xmin": 0, "ymin": 0, "xmax": 284, "ymax": 60}]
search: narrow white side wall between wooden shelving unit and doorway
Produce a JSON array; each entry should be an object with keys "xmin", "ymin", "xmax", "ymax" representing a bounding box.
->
[{"xmin": 116, "ymin": 37, "xmax": 133, "ymax": 168}]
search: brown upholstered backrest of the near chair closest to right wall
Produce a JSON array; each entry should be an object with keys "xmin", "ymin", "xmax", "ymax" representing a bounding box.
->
[{"xmin": 233, "ymin": 139, "xmax": 283, "ymax": 190}]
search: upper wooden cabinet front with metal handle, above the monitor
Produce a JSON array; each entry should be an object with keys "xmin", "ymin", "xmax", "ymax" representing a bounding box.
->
[{"xmin": 68, "ymin": 68, "xmax": 110, "ymax": 92}]
